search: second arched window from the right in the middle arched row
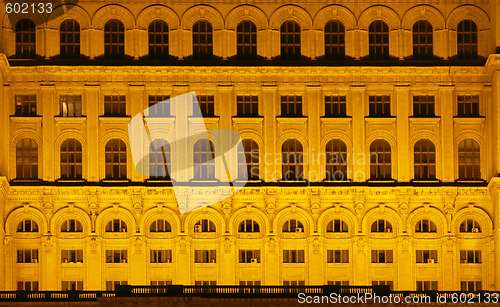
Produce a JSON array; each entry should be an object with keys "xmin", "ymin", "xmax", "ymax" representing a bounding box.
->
[{"xmin": 413, "ymin": 140, "xmax": 436, "ymax": 180}]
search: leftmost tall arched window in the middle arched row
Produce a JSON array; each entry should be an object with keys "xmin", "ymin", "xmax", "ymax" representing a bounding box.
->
[{"xmin": 16, "ymin": 139, "xmax": 38, "ymax": 180}]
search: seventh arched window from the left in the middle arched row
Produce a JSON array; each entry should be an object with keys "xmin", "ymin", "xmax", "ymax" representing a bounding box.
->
[{"xmin": 281, "ymin": 139, "xmax": 304, "ymax": 180}]
